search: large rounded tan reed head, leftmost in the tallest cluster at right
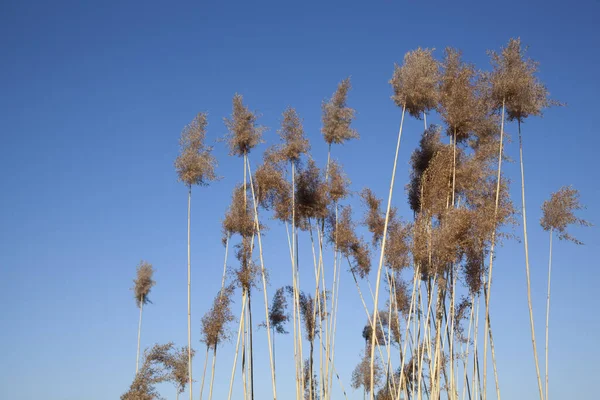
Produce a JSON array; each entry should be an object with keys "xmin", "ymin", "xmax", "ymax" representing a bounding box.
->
[{"xmin": 390, "ymin": 47, "xmax": 439, "ymax": 119}]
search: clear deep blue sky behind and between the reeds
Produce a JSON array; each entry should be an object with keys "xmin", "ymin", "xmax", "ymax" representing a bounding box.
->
[{"xmin": 0, "ymin": 0, "xmax": 600, "ymax": 400}]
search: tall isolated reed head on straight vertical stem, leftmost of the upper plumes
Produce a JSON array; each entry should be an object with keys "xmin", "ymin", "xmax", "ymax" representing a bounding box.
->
[{"xmin": 175, "ymin": 113, "xmax": 218, "ymax": 187}]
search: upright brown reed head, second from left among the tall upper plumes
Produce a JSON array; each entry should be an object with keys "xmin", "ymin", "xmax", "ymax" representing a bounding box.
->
[{"xmin": 223, "ymin": 93, "xmax": 266, "ymax": 156}]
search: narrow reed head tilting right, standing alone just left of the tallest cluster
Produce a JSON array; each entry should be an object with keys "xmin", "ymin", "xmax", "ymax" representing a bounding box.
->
[{"xmin": 321, "ymin": 78, "xmax": 359, "ymax": 147}]
